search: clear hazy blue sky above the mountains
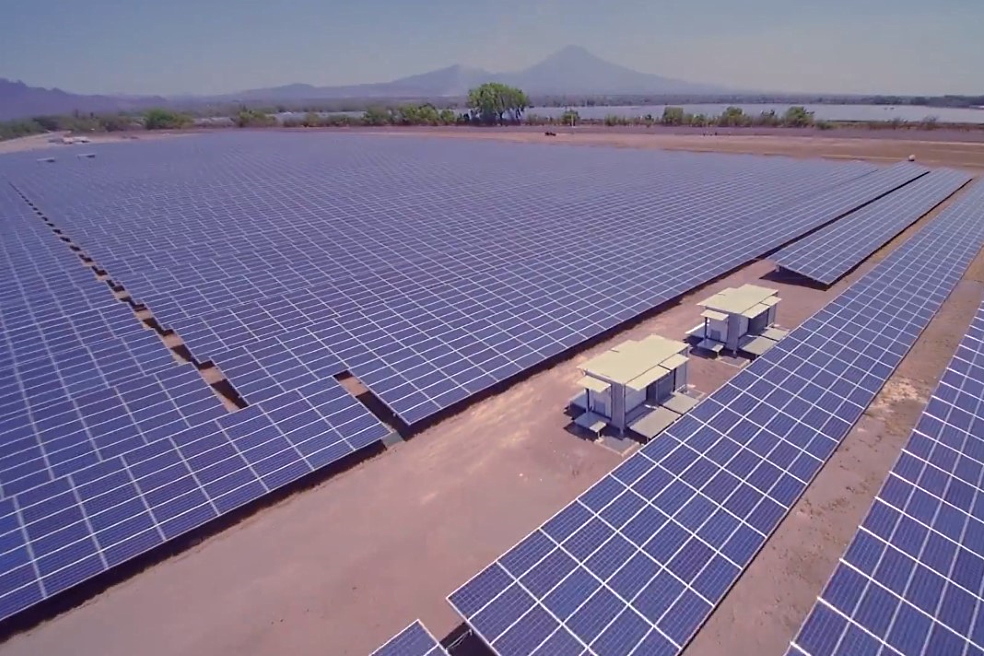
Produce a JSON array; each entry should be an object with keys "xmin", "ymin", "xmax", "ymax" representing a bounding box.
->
[{"xmin": 0, "ymin": 0, "xmax": 984, "ymax": 94}]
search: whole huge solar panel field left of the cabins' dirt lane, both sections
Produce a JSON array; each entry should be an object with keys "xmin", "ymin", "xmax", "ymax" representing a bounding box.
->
[{"xmin": 0, "ymin": 134, "xmax": 960, "ymax": 619}]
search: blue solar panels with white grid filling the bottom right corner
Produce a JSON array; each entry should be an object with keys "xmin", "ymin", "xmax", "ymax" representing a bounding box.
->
[{"xmin": 789, "ymin": 305, "xmax": 984, "ymax": 656}]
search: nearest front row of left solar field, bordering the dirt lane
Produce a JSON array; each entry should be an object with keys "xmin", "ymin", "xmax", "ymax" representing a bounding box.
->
[{"xmin": 0, "ymin": 381, "xmax": 388, "ymax": 619}]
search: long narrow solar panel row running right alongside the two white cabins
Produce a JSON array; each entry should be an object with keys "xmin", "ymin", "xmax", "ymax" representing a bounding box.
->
[{"xmin": 449, "ymin": 179, "xmax": 984, "ymax": 656}]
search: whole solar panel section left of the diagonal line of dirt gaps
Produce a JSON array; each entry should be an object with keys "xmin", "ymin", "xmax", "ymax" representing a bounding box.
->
[{"xmin": 0, "ymin": 185, "xmax": 389, "ymax": 619}]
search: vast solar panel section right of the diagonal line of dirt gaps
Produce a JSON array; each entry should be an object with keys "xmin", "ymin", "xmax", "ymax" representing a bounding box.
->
[{"xmin": 1, "ymin": 134, "xmax": 926, "ymax": 424}]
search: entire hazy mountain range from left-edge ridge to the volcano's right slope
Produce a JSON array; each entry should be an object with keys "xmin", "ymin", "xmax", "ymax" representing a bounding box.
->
[{"xmin": 0, "ymin": 46, "xmax": 734, "ymax": 120}]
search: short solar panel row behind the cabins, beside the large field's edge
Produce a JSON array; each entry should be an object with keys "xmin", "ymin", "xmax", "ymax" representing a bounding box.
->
[{"xmin": 772, "ymin": 169, "xmax": 971, "ymax": 285}]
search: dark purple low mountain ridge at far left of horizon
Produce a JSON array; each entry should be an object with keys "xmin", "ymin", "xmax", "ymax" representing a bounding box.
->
[{"xmin": 0, "ymin": 78, "xmax": 167, "ymax": 121}]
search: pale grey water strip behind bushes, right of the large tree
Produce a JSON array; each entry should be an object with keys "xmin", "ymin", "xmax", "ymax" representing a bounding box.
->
[{"xmin": 527, "ymin": 104, "xmax": 984, "ymax": 124}]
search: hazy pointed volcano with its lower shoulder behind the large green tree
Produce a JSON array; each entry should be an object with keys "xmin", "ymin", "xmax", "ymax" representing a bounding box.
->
[{"xmin": 225, "ymin": 46, "xmax": 733, "ymax": 101}]
